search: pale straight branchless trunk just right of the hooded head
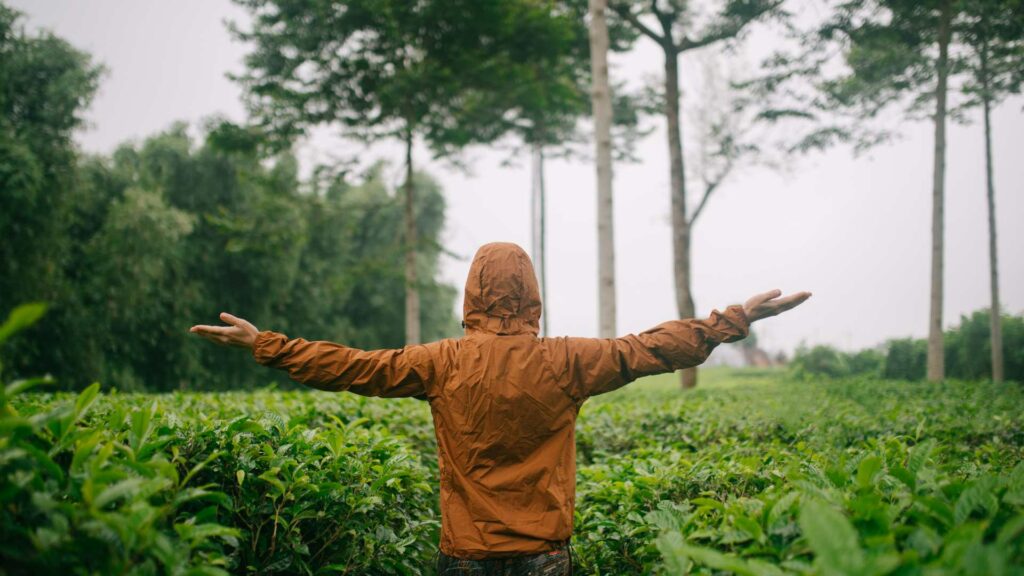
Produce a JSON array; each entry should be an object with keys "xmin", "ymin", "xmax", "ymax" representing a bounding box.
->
[{"xmin": 590, "ymin": 0, "xmax": 616, "ymax": 338}]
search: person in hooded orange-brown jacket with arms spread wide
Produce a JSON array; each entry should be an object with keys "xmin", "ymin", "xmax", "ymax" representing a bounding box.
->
[{"xmin": 191, "ymin": 243, "xmax": 810, "ymax": 576}]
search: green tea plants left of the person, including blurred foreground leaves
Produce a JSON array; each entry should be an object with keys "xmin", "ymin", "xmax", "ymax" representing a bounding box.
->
[{"xmin": 0, "ymin": 306, "xmax": 438, "ymax": 575}]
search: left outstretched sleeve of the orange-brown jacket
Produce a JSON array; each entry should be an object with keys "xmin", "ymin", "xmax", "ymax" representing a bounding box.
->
[{"xmin": 253, "ymin": 331, "xmax": 434, "ymax": 399}]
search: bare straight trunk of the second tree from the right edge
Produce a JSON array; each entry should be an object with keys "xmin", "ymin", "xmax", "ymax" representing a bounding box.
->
[{"xmin": 928, "ymin": 0, "xmax": 952, "ymax": 382}]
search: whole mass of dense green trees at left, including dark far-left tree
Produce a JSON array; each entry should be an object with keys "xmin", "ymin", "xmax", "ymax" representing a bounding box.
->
[{"xmin": 0, "ymin": 6, "xmax": 458, "ymax": 390}]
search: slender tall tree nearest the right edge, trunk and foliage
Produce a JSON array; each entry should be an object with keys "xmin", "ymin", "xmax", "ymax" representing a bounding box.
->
[{"xmin": 961, "ymin": 0, "xmax": 1024, "ymax": 382}]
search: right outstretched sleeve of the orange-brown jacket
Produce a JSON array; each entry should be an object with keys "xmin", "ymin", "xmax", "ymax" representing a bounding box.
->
[{"xmin": 565, "ymin": 304, "xmax": 750, "ymax": 402}]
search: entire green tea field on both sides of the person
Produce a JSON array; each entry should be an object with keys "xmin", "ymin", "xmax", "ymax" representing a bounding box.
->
[{"xmin": 0, "ymin": 369, "xmax": 1024, "ymax": 575}]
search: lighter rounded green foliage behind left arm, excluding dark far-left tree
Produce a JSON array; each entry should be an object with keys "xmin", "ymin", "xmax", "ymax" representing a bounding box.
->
[{"xmin": 0, "ymin": 120, "xmax": 457, "ymax": 390}]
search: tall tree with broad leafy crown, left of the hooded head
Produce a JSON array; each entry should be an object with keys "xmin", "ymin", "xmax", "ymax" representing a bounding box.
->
[{"xmin": 236, "ymin": 0, "xmax": 585, "ymax": 343}]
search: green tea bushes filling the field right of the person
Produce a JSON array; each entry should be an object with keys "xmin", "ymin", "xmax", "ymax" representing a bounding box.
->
[{"xmin": 575, "ymin": 368, "xmax": 1024, "ymax": 575}]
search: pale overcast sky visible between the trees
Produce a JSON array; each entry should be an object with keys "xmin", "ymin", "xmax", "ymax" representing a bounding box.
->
[{"xmin": 8, "ymin": 0, "xmax": 1024, "ymax": 351}]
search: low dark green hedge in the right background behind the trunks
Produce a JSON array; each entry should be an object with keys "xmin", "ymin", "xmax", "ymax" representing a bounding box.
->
[{"xmin": 790, "ymin": 310, "xmax": 1024, "ymax": 382}]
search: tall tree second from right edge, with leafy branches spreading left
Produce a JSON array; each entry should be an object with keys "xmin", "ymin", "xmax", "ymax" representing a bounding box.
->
[{"xmin": 749, "ymin": 0, "xmax": 964, "ymax": 380}]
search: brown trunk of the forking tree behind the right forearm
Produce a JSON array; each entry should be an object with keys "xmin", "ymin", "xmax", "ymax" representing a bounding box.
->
[{"xmin": 664, "ymin": 48, "xmax": 697, "ymax": 388}]
